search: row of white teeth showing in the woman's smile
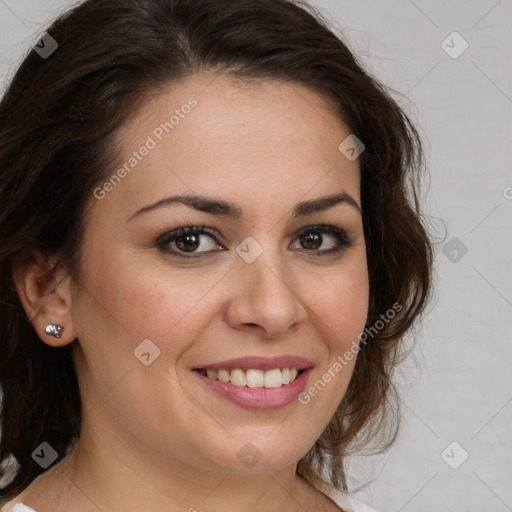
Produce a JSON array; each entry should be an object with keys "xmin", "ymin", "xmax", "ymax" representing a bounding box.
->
[{"xmin": 201, "ymin": 368, "xmax": 299, "ymax": 388}]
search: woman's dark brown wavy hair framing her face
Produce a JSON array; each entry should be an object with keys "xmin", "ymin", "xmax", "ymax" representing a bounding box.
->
[{"xmin": 0, "ymin": 0, "xmax": 432, "ymax": 504}]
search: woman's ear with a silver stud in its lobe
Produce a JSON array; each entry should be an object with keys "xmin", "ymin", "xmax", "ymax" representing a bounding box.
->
[{"xmin": 14, "ymin": 253, "xmax": 76, "ymax": 347}]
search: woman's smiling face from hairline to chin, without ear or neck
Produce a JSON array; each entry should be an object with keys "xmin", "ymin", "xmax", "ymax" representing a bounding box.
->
[{"xmin": 71, "ymin": 75, "xmax": 368, "ymax": 471}]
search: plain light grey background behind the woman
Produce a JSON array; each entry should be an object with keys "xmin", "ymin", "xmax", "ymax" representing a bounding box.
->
[{"xmin": 0, "ymin": 0, "xmax": 512, "ymax": 512}]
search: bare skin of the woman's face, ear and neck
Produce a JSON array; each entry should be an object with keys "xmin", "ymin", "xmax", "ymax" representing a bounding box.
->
[{"xmin": 10, "ymin": 75, "xmax": 368, "ymax": 512}]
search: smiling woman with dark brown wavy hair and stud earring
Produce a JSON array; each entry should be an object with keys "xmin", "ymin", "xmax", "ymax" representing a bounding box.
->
[{"xmin": 0, "ymin": 0, "xmax": 431, "ymax": 512}]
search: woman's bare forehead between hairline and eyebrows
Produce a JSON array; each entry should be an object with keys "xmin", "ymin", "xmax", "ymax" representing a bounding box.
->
[{"xmin": 97, "ymin": 75, "xmax": 359, "ymax": 220}]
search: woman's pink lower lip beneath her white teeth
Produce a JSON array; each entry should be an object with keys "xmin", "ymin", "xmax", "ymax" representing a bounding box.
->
[{"xmin": 194, "ymin": 368, "xmax": 311, "ymax": 409}]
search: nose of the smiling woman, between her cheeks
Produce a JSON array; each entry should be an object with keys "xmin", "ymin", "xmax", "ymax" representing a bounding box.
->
[{"xmin": 226, "ymin": 241, "xmax": 307, "ymax": 338}]
